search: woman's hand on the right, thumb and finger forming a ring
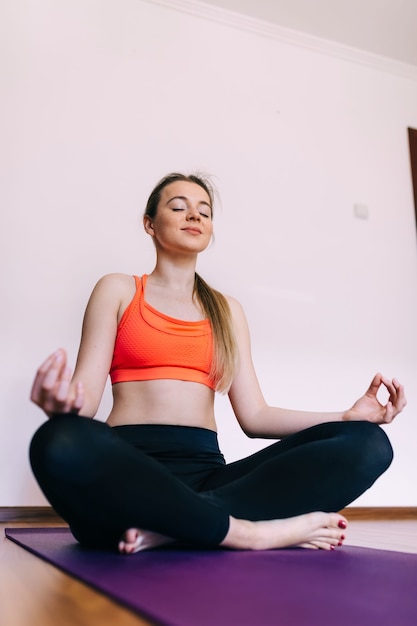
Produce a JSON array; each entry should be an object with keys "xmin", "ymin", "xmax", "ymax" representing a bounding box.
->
[{"xmin": 343, "ymin": 374, "xmax": 407, "ymax": 424}]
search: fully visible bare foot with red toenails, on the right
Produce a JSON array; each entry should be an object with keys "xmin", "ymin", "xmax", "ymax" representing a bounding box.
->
[{"xmin": 221, "ymin": 512, "xmax": 347, "ymax": 550}]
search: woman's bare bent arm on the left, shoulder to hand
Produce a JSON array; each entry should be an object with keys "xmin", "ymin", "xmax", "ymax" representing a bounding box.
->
[{"xmin": 31, "ymin": 274, "xmax": 134, "ymax": 417}]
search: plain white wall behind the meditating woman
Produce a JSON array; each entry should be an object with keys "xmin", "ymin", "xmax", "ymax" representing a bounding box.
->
[{"xmin": 0, "ymin": 0, "xmax": 417, "ymax": 506}]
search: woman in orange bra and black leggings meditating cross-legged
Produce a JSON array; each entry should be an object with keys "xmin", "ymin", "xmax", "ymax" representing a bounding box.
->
[{"xmin": 30, "ymin": 174, "xmax": 406, "ymax": 554}]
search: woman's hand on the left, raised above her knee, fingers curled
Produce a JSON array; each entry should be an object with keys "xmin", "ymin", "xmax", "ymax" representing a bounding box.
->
[{"xmin": 30, "ymin": 350, "xmax": 84, "ymax": 417}]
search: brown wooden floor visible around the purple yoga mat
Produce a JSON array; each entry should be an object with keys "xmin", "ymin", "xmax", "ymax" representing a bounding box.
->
[{"xmin": 0, "ymin": 513, "xmax": 417, "ymax": 626}]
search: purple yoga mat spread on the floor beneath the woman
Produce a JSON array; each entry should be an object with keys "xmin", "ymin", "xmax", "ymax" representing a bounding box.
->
[{"xmin": 5, "ymin": 528, "xmax": 417, "ymax": 626}]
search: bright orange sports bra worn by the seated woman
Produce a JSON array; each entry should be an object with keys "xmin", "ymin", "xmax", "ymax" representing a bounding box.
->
[{"xmin": 110, "ymin": 274, "xmax": 215, "ymax": 389}]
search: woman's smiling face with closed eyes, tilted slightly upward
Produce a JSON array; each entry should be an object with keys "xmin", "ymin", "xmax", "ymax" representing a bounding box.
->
[{"xmin": 144, "ymin": 181, "xmax": 213, "ymax": 254}]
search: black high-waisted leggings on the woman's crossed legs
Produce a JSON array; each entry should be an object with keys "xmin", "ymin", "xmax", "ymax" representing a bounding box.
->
[{"xmin": 30, "ymin": 414, "xmax": 392, "ymax": 548}]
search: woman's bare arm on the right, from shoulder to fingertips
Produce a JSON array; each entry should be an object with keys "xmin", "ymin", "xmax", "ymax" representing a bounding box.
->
[{"xmin": 228, "ymin": 298, "xmax": 406, "ymax": 439}]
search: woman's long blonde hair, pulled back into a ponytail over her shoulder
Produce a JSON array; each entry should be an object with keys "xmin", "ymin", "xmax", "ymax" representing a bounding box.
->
[{"xmin": 145, "ymin": 172, "xmax": 238, "ymax": 393}]
